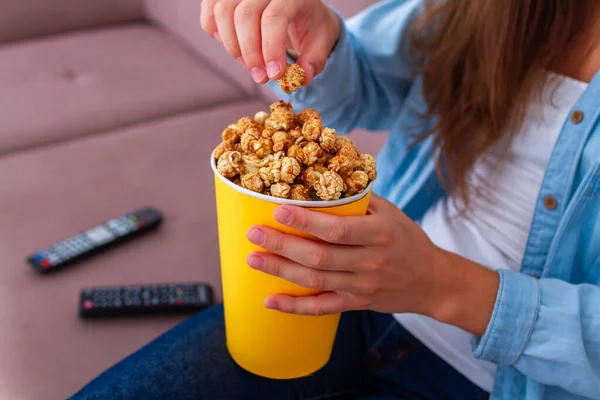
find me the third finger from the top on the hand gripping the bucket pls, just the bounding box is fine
[247,252,355,291]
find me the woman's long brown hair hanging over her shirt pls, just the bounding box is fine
[409,0,598,204]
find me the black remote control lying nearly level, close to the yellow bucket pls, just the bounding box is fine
[79,283,214,318]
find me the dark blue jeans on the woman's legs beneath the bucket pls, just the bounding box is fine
[71,305,488,400]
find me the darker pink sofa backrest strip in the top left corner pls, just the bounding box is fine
[0,0,144,43]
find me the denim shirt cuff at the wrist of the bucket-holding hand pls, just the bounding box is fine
[472,270,541,365]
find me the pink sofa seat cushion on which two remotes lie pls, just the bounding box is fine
[0,102,267,400]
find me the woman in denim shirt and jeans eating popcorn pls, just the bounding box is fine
[73,0,600,400]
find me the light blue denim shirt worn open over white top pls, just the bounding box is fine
[270,0,600,400]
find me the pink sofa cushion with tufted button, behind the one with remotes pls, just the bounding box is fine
[0,25,243,154]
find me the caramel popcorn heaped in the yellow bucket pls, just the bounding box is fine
[214,101,377,201]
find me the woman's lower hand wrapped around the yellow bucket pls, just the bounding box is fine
[248,195,498,334]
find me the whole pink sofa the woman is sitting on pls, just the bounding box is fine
[0,0,384,400]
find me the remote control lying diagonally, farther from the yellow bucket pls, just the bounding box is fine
[27,207,162,273]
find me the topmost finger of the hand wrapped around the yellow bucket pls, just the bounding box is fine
[275,205,391,246]
